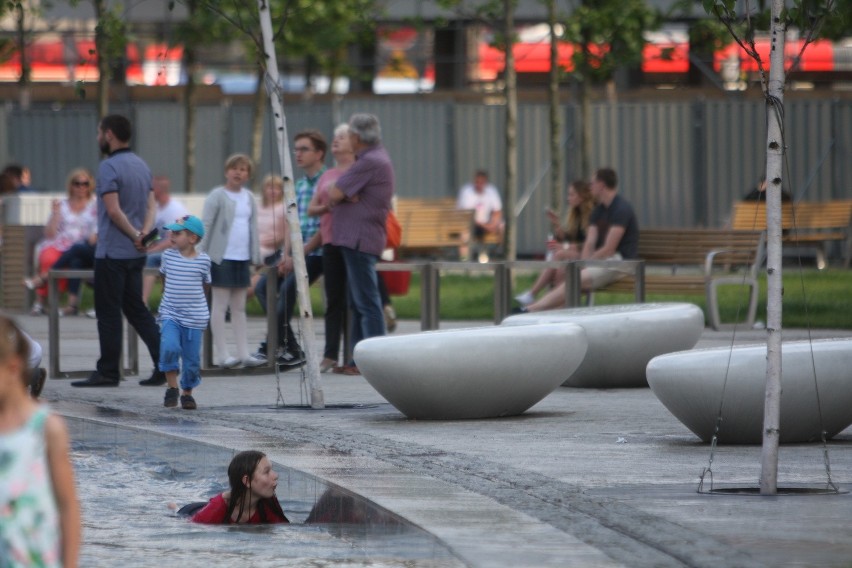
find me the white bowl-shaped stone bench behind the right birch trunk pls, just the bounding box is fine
[648,339,852,444]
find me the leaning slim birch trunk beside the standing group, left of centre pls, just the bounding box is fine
[257,0,325,408]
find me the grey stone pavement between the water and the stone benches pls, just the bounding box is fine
[20,316,852,566]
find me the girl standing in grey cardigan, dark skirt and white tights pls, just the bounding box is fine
[199,154,265,368]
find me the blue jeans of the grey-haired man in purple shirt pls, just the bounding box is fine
[340,247,385,358]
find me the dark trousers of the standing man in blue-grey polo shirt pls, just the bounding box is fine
[95,256,160,379]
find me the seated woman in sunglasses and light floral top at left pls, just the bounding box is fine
[24,168,98,315]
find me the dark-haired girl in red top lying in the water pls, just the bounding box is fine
[190,450,290,525]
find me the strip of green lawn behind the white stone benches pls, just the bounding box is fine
[140,267,852,329]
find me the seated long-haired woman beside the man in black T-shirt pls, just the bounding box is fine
[515,180,595,306]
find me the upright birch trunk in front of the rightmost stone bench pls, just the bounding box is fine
[760,0,786,495]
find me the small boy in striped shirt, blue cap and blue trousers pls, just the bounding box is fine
[159,215,210,410]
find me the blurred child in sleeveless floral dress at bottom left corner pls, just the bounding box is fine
[0,314,80,568]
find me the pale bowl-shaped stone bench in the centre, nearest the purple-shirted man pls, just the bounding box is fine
[355,323,586,420]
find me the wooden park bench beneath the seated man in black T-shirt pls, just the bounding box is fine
[588,229,765,329]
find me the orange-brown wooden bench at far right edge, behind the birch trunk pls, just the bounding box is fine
[731,199,852,269]
